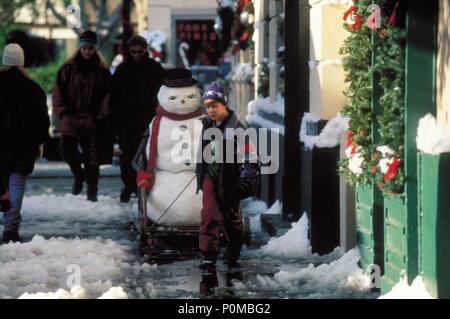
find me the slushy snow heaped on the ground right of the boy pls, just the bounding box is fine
[239,201,376,298]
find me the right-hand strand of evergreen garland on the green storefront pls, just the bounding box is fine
[374,1,406,196]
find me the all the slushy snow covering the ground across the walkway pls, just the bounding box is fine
[0,194,373,298]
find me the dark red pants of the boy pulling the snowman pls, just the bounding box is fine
[199,175,243,263]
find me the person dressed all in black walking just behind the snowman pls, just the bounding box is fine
[110,36,164,202]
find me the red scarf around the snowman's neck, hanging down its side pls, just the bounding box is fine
[136,105,202,190]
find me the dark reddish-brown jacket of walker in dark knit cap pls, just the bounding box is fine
[53,53,111,137]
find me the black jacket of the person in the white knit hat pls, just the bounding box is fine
[0,67,50,175]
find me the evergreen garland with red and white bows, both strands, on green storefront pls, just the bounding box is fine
[339,0,406,196]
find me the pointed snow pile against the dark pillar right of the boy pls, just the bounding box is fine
[261,213,311,258]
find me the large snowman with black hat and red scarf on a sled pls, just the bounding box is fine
[145,69,202,226]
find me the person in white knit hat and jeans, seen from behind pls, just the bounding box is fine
[0,44,50,243]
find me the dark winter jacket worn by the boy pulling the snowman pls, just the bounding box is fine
[196,109,259,205]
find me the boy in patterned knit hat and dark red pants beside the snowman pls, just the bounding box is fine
[197,82,259,280]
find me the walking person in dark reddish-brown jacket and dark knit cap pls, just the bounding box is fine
[53,31,112,202]
